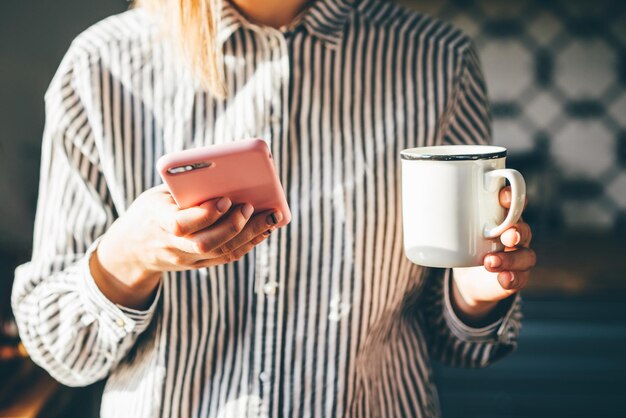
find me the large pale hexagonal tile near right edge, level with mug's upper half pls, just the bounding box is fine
[551,121,616,177]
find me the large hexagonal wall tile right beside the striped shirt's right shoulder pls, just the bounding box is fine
[480,39,533,101]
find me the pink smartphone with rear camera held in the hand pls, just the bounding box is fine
[157,139,291,227]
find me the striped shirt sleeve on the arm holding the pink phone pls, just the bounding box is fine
[11,44,161,386]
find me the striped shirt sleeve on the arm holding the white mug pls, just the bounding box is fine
[420,40,522,367]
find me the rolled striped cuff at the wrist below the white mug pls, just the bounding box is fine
[443,269,521,344]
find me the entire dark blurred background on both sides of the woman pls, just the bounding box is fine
[0,0,626,418]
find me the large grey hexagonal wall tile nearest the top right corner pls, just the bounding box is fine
[555,39,617,99]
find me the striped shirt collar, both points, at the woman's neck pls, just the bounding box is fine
[217,0,356,47]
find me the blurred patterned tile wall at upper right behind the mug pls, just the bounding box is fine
[399,0,626,233]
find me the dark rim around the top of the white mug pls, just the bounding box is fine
[400,145,506,161]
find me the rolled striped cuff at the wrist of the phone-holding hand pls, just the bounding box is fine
[80,238,162,340]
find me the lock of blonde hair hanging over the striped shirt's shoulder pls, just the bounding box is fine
[133,0,226,98]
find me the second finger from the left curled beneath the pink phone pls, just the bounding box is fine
[188,203,254,258]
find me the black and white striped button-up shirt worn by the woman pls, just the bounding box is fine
[12,0,521,418]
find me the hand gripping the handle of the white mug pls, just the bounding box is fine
[453,187,536,323]
